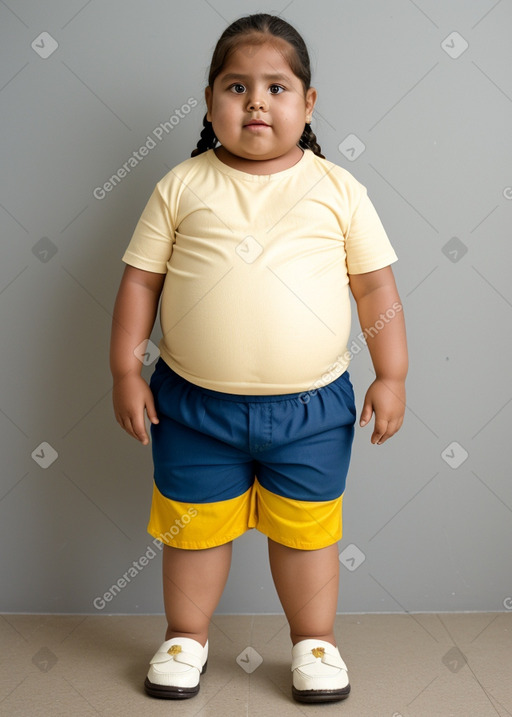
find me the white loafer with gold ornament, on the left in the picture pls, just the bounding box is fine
[144,637,208,700]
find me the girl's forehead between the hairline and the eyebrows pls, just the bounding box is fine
[219,41,300,82]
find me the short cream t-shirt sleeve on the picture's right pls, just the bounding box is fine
[345,185,398,274]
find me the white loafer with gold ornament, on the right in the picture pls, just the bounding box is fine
[292,640,350,702]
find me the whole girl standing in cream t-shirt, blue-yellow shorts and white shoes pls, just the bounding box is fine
[111,14,407,702]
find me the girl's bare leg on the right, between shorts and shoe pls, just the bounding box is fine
[268,538,340,646]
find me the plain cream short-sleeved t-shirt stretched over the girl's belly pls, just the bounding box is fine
[123,150,397,395]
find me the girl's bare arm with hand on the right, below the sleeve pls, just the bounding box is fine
[349,266,408,445]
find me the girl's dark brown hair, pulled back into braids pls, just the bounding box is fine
[191,13,324,158]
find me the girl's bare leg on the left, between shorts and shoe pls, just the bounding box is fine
[163,543,232,646]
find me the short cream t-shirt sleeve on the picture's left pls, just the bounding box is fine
[123,184,175,274]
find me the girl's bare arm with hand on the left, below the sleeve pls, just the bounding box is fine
[110,266,165,445]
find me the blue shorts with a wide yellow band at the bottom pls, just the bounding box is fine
[148,358,356,550]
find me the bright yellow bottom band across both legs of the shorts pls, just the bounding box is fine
[148,480,343,550]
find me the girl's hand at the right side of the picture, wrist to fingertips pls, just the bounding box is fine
[359,378,405,446]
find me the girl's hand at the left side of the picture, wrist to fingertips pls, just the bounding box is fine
[112,373,159,446]
